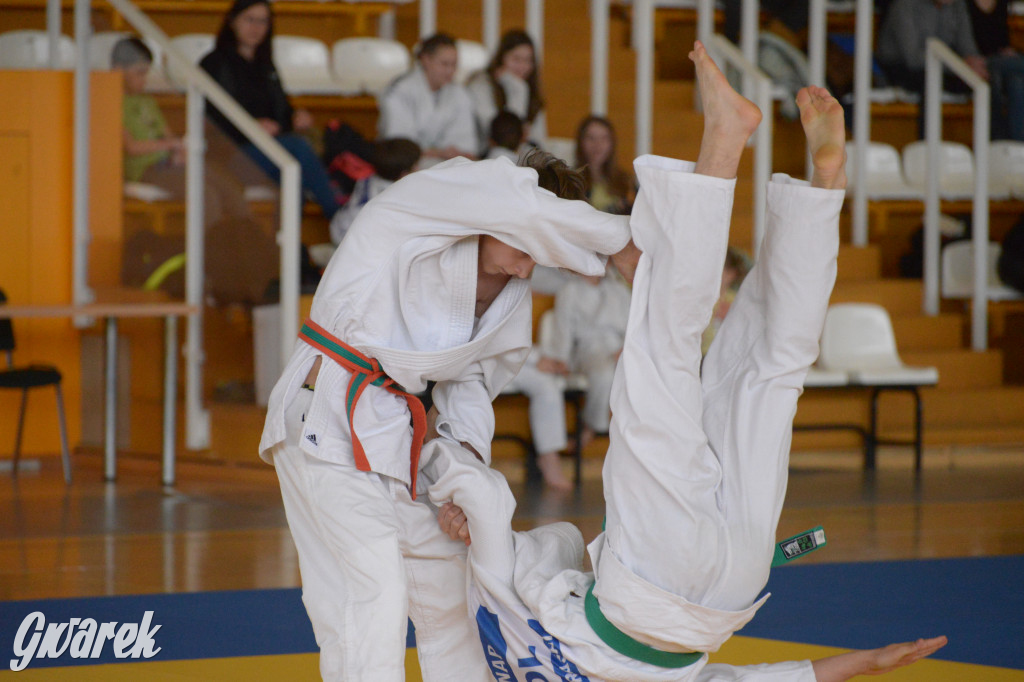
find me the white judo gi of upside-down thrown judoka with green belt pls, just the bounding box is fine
[423,157,844,682]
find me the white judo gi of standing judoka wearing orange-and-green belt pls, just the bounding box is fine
[260,159,630,682]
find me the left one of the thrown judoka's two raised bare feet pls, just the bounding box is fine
[690,40,761,178]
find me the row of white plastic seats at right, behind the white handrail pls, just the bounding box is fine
[846,140,1024,200]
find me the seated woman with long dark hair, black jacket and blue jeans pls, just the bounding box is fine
[200,0,342,220]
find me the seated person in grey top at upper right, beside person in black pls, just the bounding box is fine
[876,0,988,116]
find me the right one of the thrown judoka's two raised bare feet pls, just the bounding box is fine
[797,86,846,189]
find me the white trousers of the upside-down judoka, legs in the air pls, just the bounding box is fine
[595,165,843,614]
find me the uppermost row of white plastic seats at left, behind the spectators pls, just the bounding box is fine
[0,31,489,95]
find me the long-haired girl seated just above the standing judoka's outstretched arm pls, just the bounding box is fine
[575,116,636,215]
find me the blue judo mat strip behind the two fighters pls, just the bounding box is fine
[0,556,1024,670]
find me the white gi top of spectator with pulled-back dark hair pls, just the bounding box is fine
[378,65,480,156]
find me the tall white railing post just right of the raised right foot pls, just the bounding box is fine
[852,0,874,247]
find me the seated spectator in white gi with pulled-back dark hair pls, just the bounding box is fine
[378,33,479,165]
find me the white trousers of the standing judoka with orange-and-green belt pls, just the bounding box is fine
[273,390,489,682]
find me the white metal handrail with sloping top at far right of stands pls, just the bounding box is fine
[921,38,990,350]
